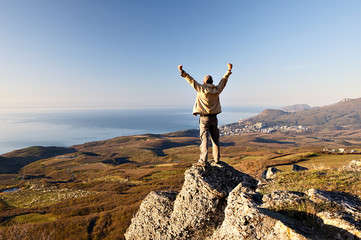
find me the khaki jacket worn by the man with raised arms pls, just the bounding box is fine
[181,71,232,115]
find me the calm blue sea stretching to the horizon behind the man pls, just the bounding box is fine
[0,106,266,155]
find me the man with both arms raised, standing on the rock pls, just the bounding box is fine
[178,63,233,165]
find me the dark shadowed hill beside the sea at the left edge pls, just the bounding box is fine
[0,146,76,174]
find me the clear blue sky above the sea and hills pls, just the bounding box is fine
[0,0,361,107]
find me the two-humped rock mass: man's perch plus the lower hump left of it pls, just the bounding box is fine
[125,162,257,239]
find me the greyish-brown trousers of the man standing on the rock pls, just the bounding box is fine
[199,115,220,163]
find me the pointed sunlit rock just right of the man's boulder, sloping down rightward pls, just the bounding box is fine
[210,187,314,240]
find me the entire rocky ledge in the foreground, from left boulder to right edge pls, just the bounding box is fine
[125,163,361,240]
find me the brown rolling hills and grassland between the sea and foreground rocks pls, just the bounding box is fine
[0,99,361,239]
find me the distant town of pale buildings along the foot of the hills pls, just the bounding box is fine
[219,120,309,136]
